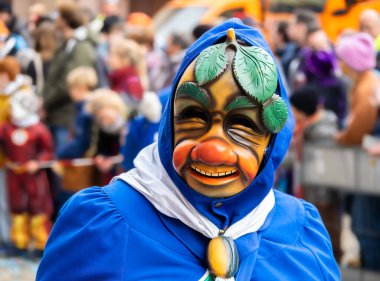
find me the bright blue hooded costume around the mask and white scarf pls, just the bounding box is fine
[37,20,340,281]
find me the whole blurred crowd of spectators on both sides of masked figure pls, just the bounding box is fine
[0,0,380,270]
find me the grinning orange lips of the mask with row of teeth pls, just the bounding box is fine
[188,163,240,186]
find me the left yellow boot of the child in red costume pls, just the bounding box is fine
[11,214,30,250]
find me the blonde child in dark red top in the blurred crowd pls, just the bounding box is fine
[108,39,144,109]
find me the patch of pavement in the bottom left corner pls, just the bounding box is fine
[0,257,39,281]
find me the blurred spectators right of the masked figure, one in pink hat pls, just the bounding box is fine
[273,10,380,270]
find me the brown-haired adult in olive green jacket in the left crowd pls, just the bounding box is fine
[42,3,95,149]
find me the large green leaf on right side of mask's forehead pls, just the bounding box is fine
[232,45,277,103]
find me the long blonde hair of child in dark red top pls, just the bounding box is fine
[111,39,149,90]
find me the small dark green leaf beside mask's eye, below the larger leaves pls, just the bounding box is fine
[262,94,288,134]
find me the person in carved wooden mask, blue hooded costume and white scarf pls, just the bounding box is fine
[37,19,340,281]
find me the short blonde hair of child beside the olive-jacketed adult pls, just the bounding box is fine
[67,66,98,90]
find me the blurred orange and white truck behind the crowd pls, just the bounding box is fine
[154,0,380,46]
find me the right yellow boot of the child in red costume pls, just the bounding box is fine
[30,214,50,251]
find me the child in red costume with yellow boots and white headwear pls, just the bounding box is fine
[0,90,54,254]
